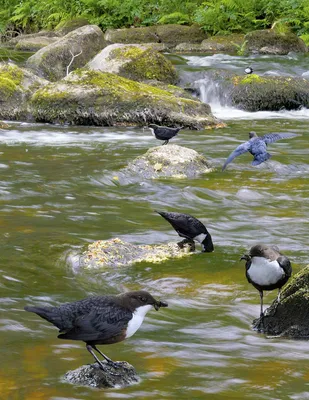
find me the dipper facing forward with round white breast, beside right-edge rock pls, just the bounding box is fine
[241,244,292,318]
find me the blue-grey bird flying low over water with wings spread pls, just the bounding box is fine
[222,132,298,171]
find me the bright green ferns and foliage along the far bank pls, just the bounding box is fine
[0,0,309,35]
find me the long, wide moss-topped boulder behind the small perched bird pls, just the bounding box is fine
[31,70,217,129]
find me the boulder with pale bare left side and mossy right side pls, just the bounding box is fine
[87,44,177,83]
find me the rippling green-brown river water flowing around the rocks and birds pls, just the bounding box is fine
[0,56,309,400]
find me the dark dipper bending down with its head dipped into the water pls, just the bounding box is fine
[155,210,214,253]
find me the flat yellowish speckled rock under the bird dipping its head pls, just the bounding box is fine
[79,238,190,269]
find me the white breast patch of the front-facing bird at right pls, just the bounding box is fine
[248,257,284,286]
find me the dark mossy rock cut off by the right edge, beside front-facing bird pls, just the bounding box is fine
[253,266,309,339]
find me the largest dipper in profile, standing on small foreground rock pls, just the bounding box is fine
[25,290,167,369]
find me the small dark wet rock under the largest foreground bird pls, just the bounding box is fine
[64,361,140,389]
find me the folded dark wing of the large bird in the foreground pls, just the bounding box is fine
[58,304,132,342]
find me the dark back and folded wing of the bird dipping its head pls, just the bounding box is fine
[157,211,208,239]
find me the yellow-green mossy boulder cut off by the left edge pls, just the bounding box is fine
[0,63,48,120]
